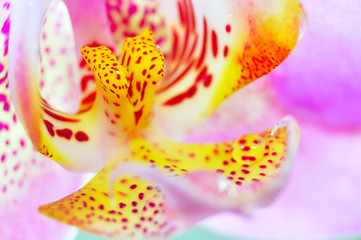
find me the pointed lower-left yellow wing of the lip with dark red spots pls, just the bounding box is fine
[39,166,174,238]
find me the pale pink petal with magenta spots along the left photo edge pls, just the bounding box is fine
[0,1,80,240]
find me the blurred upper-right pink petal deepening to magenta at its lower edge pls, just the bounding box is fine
[273,0,361,128]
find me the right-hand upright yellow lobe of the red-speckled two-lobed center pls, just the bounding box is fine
[119,29,164,128]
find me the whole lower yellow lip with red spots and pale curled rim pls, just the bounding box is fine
[40,116,298,238]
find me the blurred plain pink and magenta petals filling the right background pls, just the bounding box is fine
[193,0,361,239]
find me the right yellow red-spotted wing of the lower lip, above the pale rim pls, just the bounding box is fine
[131,115,298,190]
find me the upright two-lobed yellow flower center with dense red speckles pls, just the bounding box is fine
[81,29,164,133]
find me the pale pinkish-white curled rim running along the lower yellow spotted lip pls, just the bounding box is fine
[108,116,299,228]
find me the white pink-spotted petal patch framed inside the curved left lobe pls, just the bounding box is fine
[40,1,80,112]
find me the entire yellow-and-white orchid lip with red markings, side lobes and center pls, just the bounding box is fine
[3,0,302,238]
